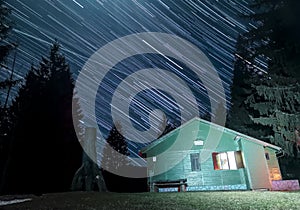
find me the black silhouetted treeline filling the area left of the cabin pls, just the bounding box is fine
[0,1,147,194]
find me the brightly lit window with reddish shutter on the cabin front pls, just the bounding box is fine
[212,151,244,170]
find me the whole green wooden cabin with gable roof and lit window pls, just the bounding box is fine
[140,118,281,192]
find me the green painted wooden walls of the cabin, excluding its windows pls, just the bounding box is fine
[142,118,279,189]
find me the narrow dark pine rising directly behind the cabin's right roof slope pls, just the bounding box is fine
[226,35,268,139]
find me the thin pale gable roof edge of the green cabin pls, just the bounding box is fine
[140,117,281,154]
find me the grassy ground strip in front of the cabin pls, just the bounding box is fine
[0,191,300,210]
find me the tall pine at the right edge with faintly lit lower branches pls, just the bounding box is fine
[246,0,300,156]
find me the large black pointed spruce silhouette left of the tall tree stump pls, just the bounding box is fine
[2,43,82,193]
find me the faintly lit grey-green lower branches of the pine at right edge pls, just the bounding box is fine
[246,75,300,156]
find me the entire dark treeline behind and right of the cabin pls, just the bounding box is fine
[227,0,300,179]
